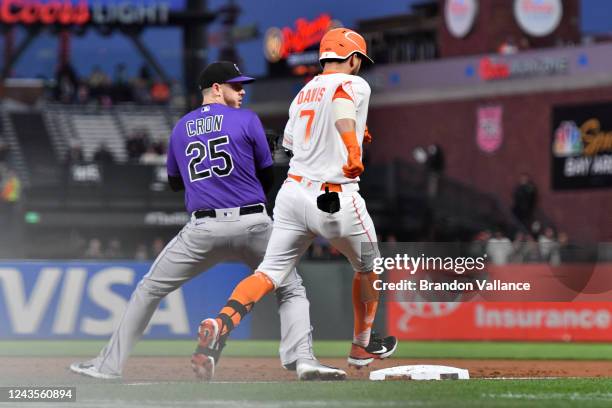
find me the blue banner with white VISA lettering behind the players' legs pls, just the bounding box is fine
[0,261,251,340]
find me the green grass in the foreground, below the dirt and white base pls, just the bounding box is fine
[5,377,612,408]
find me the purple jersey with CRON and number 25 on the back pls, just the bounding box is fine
[167,103,273,213]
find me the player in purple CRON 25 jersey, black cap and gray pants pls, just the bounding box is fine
[70,62,346,380]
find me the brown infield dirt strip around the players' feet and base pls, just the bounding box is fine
[0,357,612,383]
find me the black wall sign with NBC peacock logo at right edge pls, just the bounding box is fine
[551,101,612,190]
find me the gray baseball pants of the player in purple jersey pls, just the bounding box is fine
[92,209,314,375]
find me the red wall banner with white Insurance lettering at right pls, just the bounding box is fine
[385,258,612,342]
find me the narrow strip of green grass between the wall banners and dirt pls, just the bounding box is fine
[0,340,612,360]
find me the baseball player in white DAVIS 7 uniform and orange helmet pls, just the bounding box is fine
[194,28,397,374]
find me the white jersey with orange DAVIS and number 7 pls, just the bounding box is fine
[283,73,371,184]
